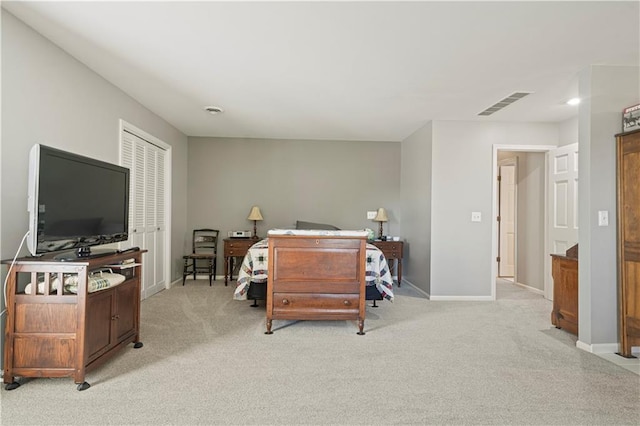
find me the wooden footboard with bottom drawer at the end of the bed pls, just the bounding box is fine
[266,231,367,335]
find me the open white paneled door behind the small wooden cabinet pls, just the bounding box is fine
[545,143,578,300]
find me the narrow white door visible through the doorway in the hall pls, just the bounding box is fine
[498,159,517,278]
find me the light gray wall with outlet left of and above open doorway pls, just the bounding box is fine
[431,121,558,299]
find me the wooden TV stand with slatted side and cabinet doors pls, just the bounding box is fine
[2,250,146,390]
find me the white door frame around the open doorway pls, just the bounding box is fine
[490,144,557,300]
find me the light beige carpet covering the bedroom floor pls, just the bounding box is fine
[0,280,640,425]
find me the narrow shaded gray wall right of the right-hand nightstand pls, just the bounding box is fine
[400,122,433,294]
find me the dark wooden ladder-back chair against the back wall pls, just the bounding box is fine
[182,229,220,286]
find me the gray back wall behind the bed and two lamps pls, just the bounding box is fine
[184,137,401,271]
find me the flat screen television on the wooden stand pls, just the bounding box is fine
[27,144,129,260]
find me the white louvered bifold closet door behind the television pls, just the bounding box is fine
[120,130,167,299]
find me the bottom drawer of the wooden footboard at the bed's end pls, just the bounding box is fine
[273,293,359,319]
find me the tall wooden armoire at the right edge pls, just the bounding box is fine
[616,130,640,358]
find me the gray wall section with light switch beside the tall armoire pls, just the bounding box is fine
[578,66,640,352]
